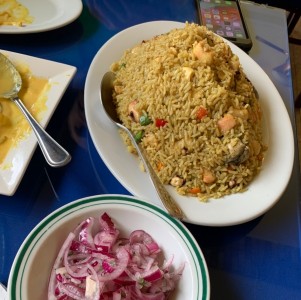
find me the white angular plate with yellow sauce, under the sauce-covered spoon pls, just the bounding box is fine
[0,50,76,196]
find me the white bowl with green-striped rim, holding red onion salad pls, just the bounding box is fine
[8,195,210,300]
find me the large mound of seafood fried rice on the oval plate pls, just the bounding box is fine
[111,23,266,201]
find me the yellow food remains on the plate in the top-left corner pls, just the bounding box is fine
[0,0,33,26]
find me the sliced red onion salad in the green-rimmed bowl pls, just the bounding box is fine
[48,213,184,300]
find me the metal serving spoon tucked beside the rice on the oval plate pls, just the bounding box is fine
[101,72,184,220]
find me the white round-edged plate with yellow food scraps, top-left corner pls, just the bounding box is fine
[0,0,83,34]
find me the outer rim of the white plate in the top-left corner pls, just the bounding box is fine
[0,0,83,34]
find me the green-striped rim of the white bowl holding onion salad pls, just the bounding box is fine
[7,194,210,300]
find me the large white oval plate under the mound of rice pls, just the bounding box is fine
[85,21,294,226]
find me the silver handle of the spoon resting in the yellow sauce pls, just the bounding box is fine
[12,97,71,167]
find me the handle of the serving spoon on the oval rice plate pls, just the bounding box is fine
[122,124,185,220]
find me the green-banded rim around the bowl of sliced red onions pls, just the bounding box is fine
[8,195,209,300]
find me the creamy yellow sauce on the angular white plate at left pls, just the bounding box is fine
[0,65,50,164]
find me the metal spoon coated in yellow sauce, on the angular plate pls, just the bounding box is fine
[0,53,71,167]
